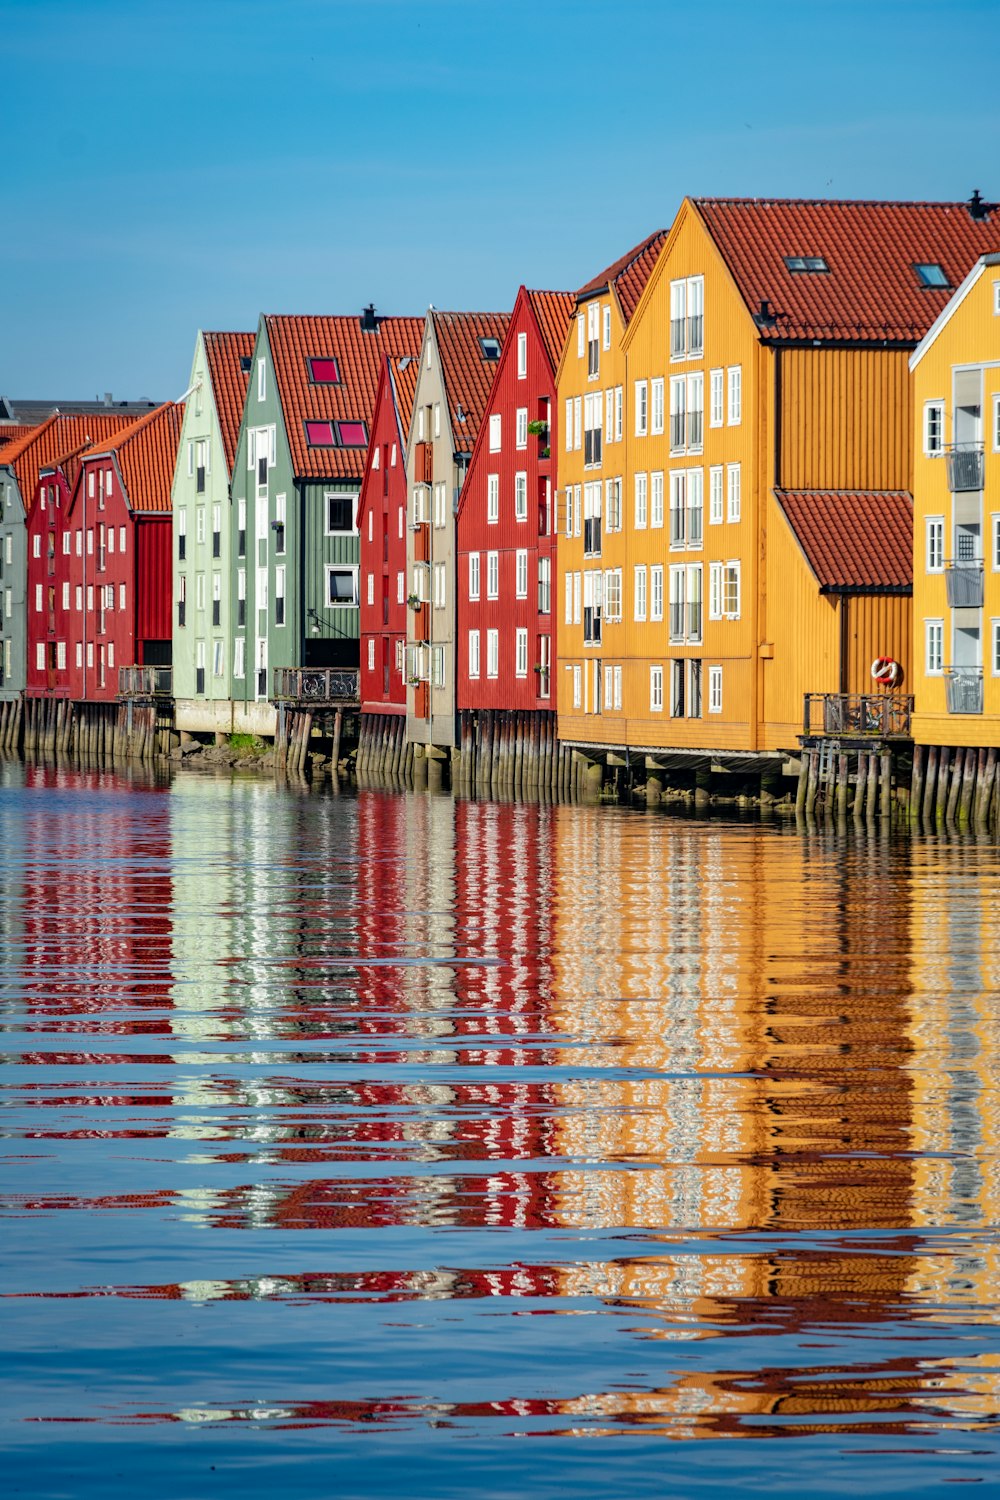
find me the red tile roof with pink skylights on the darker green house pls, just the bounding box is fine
[264,317,424,480]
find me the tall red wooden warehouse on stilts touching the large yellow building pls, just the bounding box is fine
[456,287,574,791]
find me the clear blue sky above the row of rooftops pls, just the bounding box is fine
[0,0,1000,398]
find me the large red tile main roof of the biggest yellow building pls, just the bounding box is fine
[693,198,1000,344]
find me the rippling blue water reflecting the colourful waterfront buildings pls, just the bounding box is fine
[0,764,1000,1500]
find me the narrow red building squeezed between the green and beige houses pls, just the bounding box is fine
[358,348,420,729]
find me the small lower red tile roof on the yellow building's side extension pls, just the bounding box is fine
[774,489,913,594]
